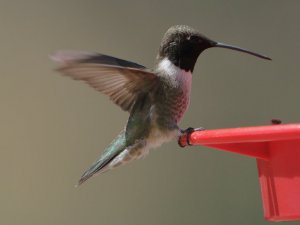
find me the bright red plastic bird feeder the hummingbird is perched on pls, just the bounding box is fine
[179,123,300,221]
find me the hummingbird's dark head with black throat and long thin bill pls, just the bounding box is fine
[158,25,270,72]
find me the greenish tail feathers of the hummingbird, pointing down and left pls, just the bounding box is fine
[76,131,126,186]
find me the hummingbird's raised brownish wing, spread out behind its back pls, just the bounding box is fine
[51,51,158,112]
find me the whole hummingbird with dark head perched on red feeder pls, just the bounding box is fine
[52,25,271,185]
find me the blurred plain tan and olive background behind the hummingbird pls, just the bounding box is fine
[0,0,300,225]
